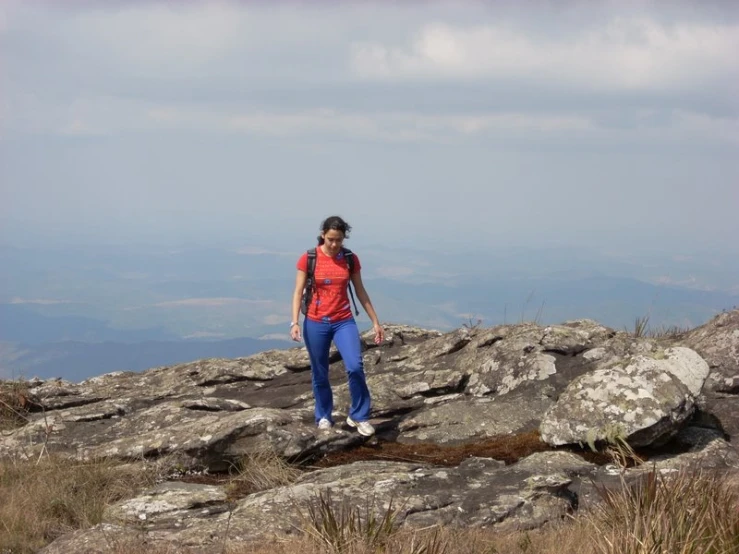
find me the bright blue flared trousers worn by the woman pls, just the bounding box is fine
[303,317,371,423]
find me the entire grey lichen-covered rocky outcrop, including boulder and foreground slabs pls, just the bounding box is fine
[0,312,739,552]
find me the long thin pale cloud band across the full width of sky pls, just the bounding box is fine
[5,90,739,144]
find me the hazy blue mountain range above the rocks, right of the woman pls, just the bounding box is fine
[368,274,739,330]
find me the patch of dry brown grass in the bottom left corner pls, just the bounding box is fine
[0,457,158,554]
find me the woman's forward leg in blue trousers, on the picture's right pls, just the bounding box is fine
[333,318,372,421]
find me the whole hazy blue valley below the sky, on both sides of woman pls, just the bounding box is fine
[0,245,739,380]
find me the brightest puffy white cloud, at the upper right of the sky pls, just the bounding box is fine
[351,18,739,90]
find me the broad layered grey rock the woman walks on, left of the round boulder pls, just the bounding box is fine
[0,320,632,464]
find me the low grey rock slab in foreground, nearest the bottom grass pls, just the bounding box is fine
[98,453,592,547]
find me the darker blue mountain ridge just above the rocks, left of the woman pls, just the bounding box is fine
[0,338,295,381]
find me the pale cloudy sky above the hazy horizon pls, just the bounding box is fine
[0,0,739,254]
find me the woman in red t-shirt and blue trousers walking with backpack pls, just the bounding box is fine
[290,216,385,437]
